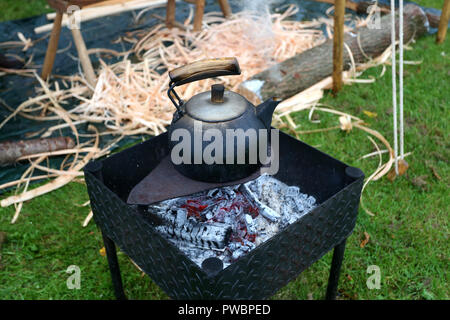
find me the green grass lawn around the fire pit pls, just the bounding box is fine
[0,0,450,299]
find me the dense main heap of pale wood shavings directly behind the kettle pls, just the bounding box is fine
[73,6,325,135]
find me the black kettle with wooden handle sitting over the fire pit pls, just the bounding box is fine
[167,58,280,183]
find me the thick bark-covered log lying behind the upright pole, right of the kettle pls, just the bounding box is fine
[239,4,428,103]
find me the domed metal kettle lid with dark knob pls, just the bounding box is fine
[185,84,251,122]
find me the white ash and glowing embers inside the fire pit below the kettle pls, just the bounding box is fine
[148,175,316,267]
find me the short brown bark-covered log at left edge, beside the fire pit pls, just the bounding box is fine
[0,137,75,166]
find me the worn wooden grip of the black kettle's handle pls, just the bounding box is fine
[169,58,241,86]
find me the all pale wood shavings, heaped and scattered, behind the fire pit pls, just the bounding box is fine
[0,6,393,222]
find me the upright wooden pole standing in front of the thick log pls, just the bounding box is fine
[332,0,345,94]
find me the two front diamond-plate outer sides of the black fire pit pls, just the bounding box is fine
[85,131,363,299]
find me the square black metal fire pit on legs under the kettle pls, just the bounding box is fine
[84,132,364,299]
